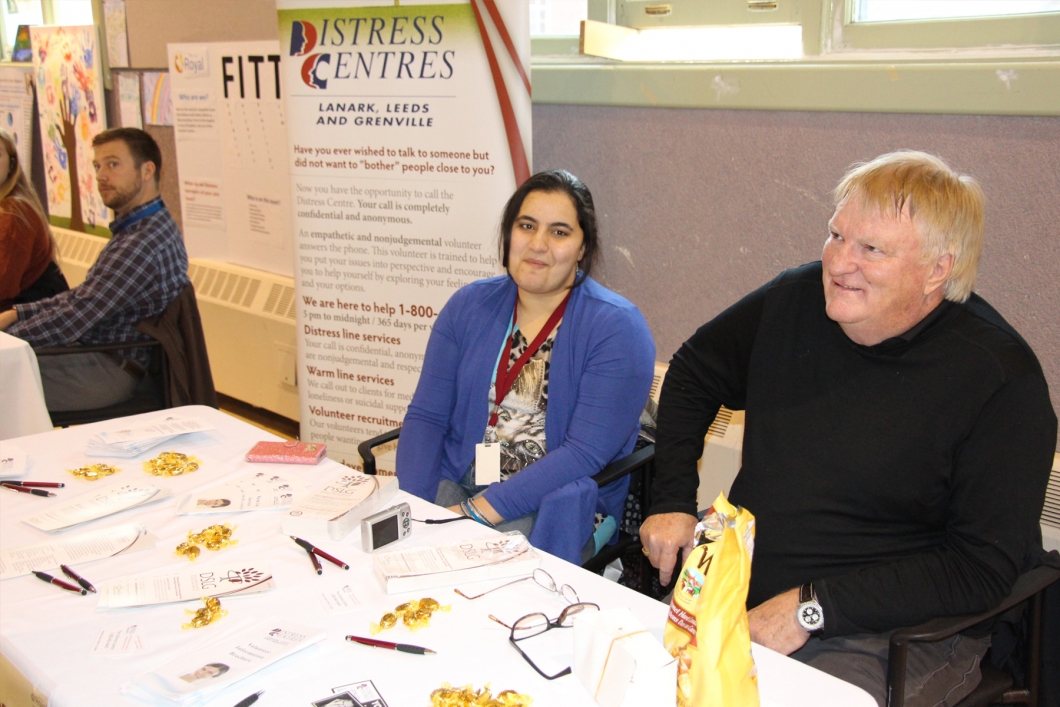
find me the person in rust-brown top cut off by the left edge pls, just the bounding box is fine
[0,130,70,312]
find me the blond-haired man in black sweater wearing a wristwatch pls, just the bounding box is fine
[640,152,1057,706]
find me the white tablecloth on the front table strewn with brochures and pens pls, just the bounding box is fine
[0,407,875,707]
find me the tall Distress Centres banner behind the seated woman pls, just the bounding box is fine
[277,0,531,466]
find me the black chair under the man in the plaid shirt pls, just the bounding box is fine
[34,339,173,427]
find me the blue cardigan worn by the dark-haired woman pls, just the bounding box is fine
[398,276,655,562]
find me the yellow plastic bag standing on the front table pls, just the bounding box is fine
[664,493,759,707]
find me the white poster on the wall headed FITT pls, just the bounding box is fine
[169,40,295,277]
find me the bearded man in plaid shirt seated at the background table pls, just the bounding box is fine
[0,127,188,411]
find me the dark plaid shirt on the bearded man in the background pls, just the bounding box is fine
[7,197,188,367]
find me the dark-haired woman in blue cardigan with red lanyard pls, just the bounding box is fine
[396,170,655,563]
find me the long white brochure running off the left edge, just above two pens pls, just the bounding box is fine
[0,523,158,580]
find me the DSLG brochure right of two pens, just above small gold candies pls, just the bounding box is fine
[98,562,276,609]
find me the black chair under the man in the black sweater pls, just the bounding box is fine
[887,551,1060,707]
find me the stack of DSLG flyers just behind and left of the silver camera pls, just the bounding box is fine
[283,471,398,541]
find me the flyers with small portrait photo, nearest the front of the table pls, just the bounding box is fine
[121,617,328,707]
